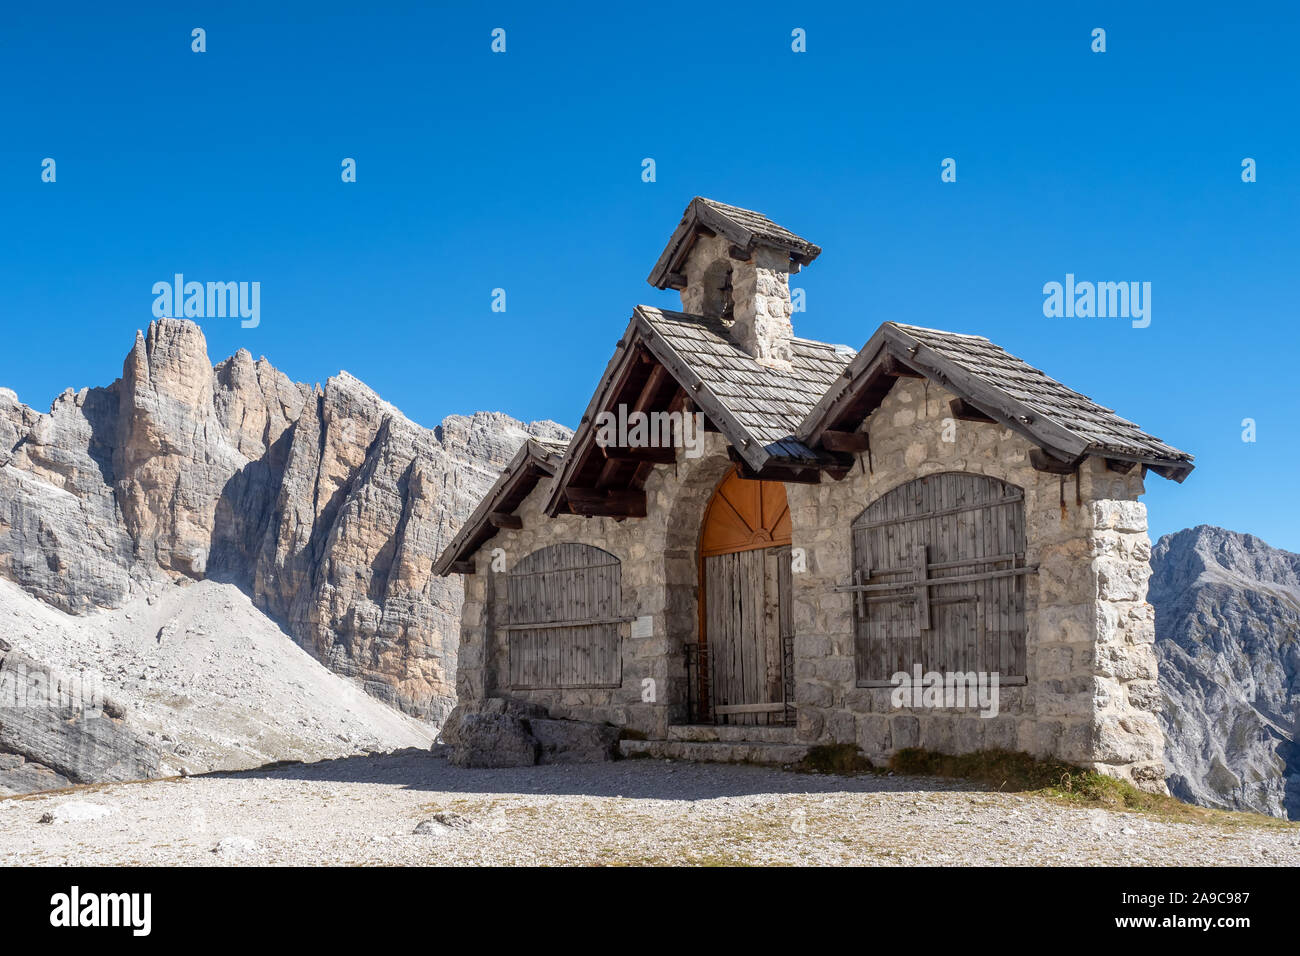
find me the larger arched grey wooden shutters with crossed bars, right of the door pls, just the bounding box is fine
[852,472,1035,687]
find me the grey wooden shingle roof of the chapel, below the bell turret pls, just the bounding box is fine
[434,314,1193,574]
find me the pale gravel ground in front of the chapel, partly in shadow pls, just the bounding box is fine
[0,750,1300,866]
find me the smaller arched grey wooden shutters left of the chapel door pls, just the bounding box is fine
[504,544,629,691]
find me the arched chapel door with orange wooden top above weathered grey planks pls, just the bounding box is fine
[697,468,794,724]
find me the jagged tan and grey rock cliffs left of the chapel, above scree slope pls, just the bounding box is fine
[0,319,568,728]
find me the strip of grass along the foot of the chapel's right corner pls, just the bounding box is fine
[889,748,1300,829]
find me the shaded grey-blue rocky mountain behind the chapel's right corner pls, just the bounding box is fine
[1149,524,1300,819]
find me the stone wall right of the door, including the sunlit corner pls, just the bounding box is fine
[787,378,1164,787]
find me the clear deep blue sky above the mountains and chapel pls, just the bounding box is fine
[0,3,1300,550]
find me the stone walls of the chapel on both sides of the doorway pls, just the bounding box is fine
[458,378,1164,788]
